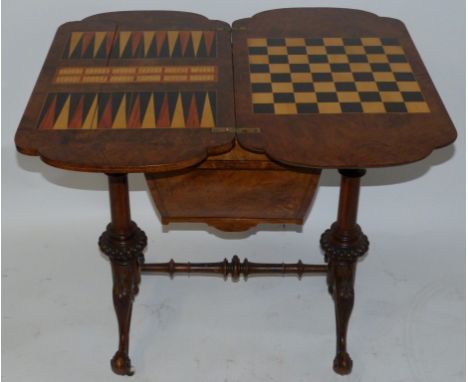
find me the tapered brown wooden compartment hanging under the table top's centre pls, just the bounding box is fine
[146,146,320,231]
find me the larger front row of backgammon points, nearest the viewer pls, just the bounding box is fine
[37,91,216,130]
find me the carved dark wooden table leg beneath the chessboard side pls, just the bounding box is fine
[320,170,369,375]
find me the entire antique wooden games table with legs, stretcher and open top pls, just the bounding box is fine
[15,8,456,375]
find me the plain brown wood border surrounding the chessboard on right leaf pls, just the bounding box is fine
[232,8,456,168]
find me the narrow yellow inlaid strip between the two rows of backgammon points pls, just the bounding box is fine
[53,66,217,84]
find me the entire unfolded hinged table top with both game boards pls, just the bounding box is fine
[16,8,456,172]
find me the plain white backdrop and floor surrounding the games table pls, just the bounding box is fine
[2,0,465,382]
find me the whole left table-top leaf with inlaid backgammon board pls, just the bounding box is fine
[15,11,235,172]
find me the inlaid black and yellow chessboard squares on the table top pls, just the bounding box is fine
[248,37,430,115]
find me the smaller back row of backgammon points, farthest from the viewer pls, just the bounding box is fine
[62,30,216,59]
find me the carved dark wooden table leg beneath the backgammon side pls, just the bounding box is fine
[99,174,147,375]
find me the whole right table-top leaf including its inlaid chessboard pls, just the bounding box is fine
[233,8,456,168]
